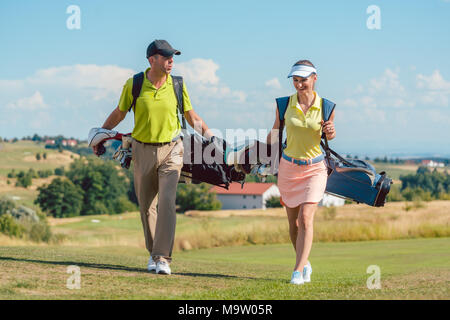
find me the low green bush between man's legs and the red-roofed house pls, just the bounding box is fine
[176,183,222,212]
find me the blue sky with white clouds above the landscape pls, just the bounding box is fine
[0,0,450,156]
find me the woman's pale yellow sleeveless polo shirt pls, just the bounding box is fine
[284,91,322,159]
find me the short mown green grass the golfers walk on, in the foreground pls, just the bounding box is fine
[0,238,450,299]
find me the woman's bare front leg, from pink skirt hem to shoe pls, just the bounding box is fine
[294,203,317,272]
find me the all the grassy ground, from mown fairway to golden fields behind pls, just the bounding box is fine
[0,141,450,300]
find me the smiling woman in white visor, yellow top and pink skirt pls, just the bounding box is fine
[267,60,336,284]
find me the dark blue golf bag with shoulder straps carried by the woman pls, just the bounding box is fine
[277,97,392,207]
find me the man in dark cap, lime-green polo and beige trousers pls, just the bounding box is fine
[94,40,212,274]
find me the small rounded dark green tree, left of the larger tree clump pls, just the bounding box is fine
[34,178,84,218]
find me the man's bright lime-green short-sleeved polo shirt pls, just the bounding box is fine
[119,68,192,143]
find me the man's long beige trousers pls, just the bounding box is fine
[132,139,184,263]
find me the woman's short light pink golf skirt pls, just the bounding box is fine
[278,157,328,208]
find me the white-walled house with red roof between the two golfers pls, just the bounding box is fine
[210,182,280,209]
